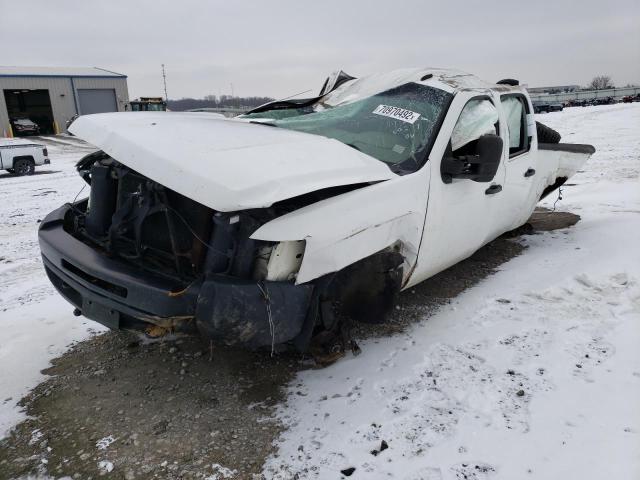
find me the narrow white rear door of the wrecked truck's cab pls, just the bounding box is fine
[500,93,541,231]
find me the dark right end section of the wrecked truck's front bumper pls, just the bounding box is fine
[196,277,313,348]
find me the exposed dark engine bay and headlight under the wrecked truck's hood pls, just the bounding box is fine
[72,152,376,284]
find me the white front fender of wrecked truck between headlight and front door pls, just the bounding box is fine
[251,168,430,285]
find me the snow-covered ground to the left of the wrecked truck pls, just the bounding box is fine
[0,137,102,437]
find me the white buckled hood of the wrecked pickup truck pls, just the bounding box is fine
[69,112,396,212]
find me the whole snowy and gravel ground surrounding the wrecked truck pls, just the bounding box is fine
[0,104,640,480]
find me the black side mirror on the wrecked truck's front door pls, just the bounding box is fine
[440,135,502,183]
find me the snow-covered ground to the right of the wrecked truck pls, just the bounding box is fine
[265,104,640,480]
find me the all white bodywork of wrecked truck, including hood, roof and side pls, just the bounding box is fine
[71,69,590,288]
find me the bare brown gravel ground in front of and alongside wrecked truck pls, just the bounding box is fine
[0,209,579,480]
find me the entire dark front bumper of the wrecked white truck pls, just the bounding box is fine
[38,205,313,348]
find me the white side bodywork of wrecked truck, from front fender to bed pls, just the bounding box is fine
[252,83,589,288]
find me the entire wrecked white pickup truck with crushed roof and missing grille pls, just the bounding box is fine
[39,69,594,350]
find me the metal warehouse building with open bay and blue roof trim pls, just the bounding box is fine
[0,66,129,137]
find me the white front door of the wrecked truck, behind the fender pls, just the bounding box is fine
[411,91,508,284]
